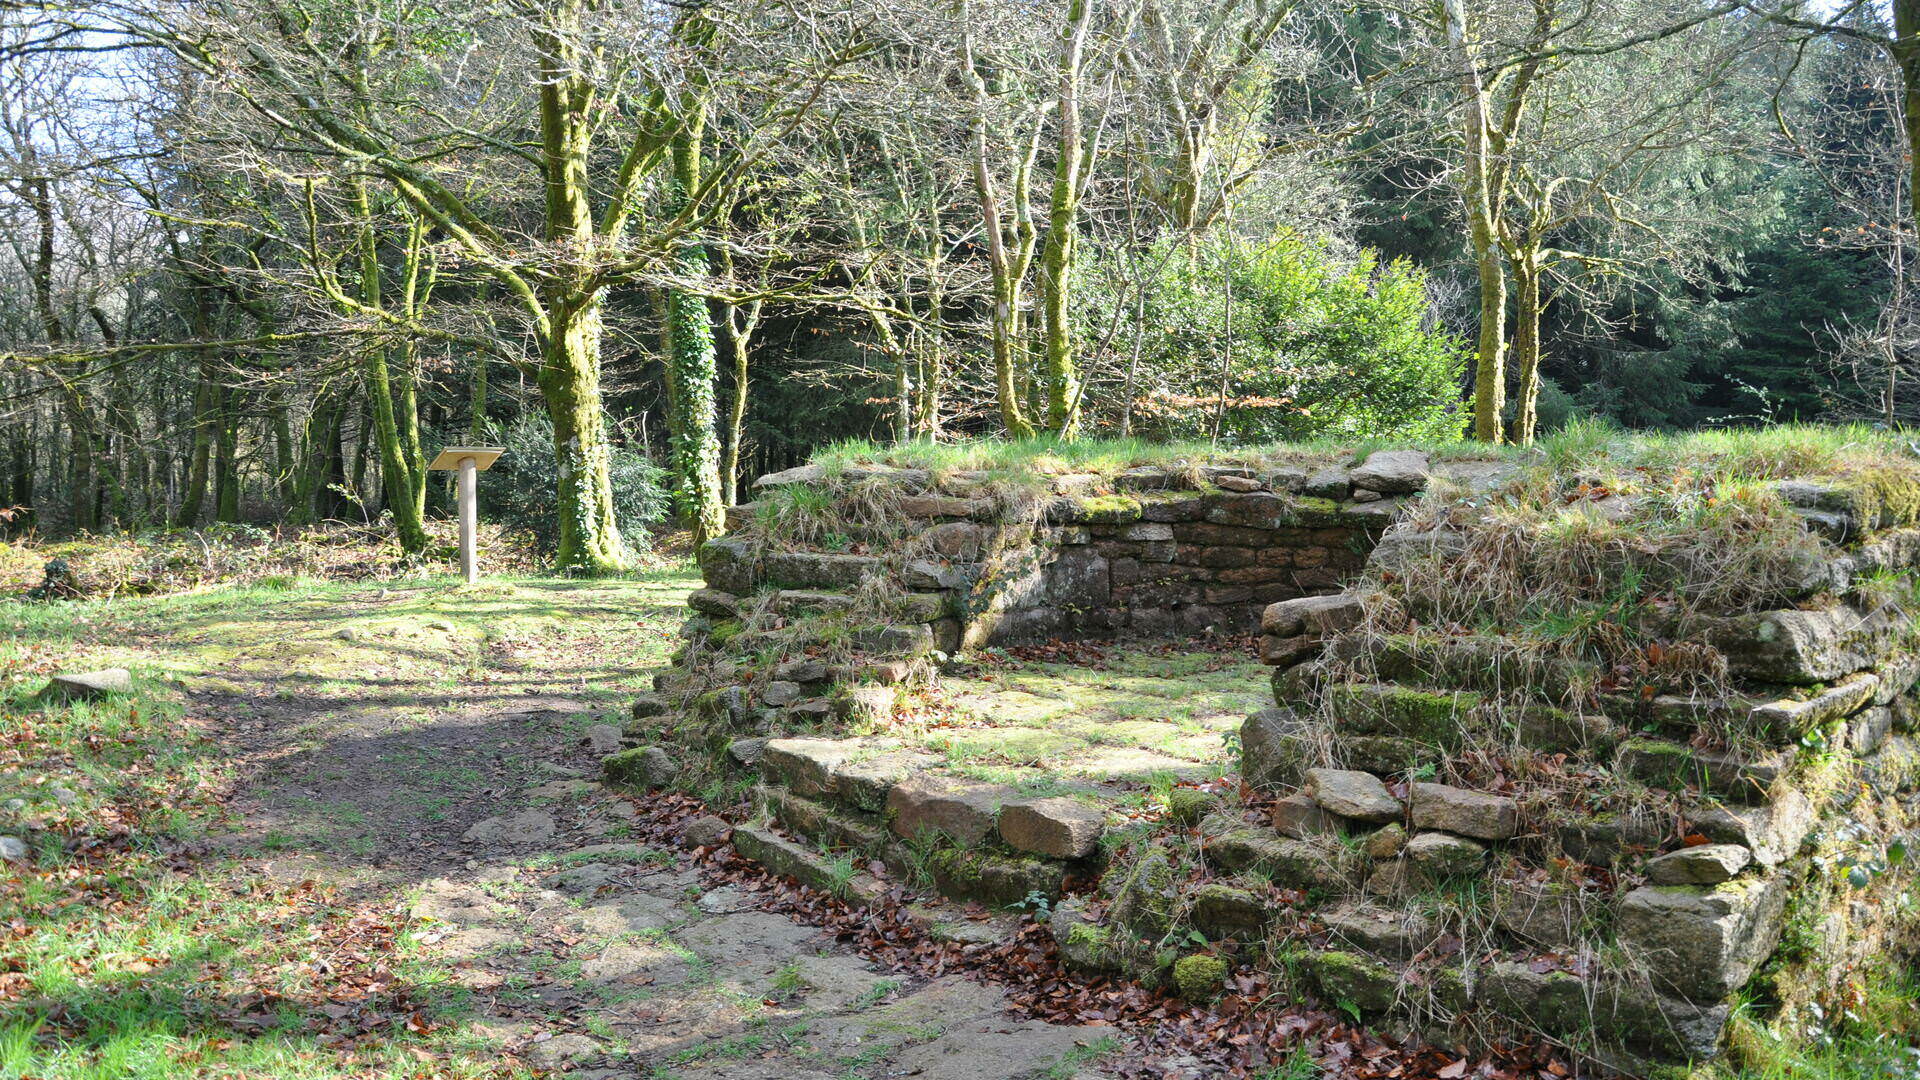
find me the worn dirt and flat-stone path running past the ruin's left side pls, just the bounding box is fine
[178,576,1112,1080]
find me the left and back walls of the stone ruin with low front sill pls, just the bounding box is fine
[609,454,1419,903]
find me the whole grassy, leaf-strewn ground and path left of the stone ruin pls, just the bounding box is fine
[0,575,1117,1080]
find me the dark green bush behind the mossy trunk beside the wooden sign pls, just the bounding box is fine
[480,411,666,557]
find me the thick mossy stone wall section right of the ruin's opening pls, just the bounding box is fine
[1228,466,1920,1074]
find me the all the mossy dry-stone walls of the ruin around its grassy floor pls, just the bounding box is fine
[609,443,1920,1074]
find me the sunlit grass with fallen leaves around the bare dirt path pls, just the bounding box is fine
[0,575,689,1080]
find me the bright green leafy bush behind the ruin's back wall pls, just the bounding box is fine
[1081,233,1467,444]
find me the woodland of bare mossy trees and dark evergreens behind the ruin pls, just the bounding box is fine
[0,0,1920,573]
